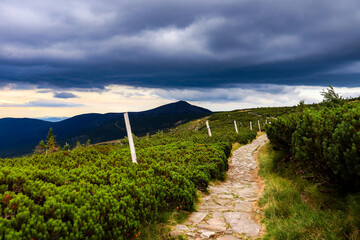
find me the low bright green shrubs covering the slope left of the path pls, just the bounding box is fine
[0,110,268,239]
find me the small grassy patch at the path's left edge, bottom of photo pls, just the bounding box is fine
[137,211,189,240]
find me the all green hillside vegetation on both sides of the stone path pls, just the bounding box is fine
[0,91,360,240]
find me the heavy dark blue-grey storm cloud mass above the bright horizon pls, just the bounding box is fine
[0,0,360,88]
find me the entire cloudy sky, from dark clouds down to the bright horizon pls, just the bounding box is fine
[0,0,360,118]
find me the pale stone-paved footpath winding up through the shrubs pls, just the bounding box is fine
[171,135,267,240]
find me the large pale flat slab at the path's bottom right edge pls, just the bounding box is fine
[224,212,261,236]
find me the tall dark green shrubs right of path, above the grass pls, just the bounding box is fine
[266,99,360,191]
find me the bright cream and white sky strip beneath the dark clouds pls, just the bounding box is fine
[0,84,360,119]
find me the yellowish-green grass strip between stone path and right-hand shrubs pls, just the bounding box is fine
[258,143,360,240]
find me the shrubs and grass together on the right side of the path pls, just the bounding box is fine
[259,86,360,239]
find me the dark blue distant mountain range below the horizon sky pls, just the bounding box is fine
[0,101,211,158]
